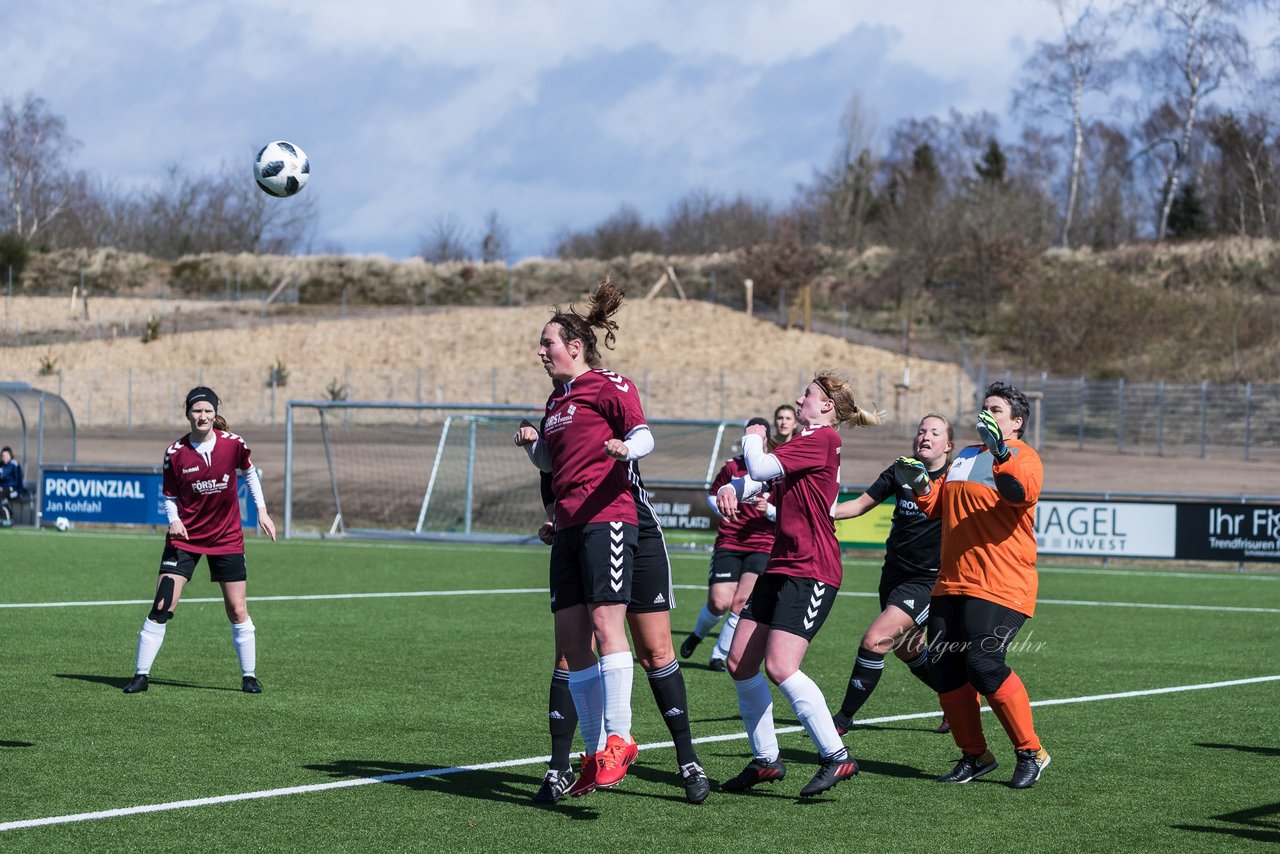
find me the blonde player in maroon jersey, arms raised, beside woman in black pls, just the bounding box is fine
[717,371,881,796]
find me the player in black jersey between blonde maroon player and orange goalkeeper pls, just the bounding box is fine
[835,414,955,735]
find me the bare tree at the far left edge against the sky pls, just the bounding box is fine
[0,92,79,243]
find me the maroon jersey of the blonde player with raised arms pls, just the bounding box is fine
[765,426,844,588]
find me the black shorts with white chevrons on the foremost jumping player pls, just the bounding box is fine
[549,522,637,611]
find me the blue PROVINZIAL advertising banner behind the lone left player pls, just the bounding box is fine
[40,469,257,528]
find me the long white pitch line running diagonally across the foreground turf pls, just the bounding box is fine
[0,675,1280,832]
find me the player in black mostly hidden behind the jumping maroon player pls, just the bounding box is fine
[534,462,710,804]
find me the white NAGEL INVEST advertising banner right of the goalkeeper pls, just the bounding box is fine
[1036,501,1178,557]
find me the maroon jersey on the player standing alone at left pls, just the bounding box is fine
[163,430,253,554]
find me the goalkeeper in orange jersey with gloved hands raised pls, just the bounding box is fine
[897,383,1050,789]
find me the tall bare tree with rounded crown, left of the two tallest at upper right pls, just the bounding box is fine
[1014,0,1121,247]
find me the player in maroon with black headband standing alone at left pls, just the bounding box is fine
[124,385,275,694]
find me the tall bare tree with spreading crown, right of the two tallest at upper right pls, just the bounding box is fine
[1132,0,1254,241]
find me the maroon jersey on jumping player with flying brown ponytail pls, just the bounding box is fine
[541,370,645,529]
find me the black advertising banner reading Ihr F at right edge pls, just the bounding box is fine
[1178,503,1280,561]
